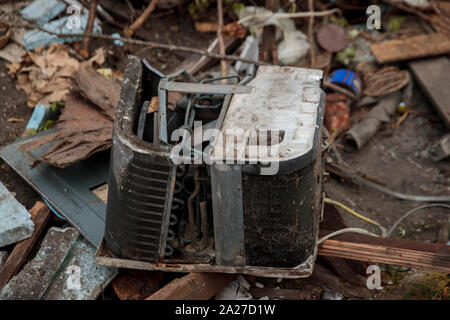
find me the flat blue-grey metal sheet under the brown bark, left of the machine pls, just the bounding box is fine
[0,130,109,247]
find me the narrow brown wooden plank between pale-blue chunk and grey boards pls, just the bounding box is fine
[0,201,51,290]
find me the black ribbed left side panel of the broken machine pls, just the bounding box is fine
[105,56,176,261]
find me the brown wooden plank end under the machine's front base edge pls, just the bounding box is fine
[146,273,234,300]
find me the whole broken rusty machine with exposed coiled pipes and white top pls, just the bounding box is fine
[96,57,325,278]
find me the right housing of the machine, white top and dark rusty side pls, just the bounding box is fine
[211,66,325,268]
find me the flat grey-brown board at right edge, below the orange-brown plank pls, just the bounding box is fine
[409,57,450,129]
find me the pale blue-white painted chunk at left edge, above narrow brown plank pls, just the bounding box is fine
[0,182,34,248]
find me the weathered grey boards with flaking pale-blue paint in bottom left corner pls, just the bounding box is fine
[0,227,117,300]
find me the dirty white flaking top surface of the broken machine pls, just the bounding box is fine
[213,66,323,162]
